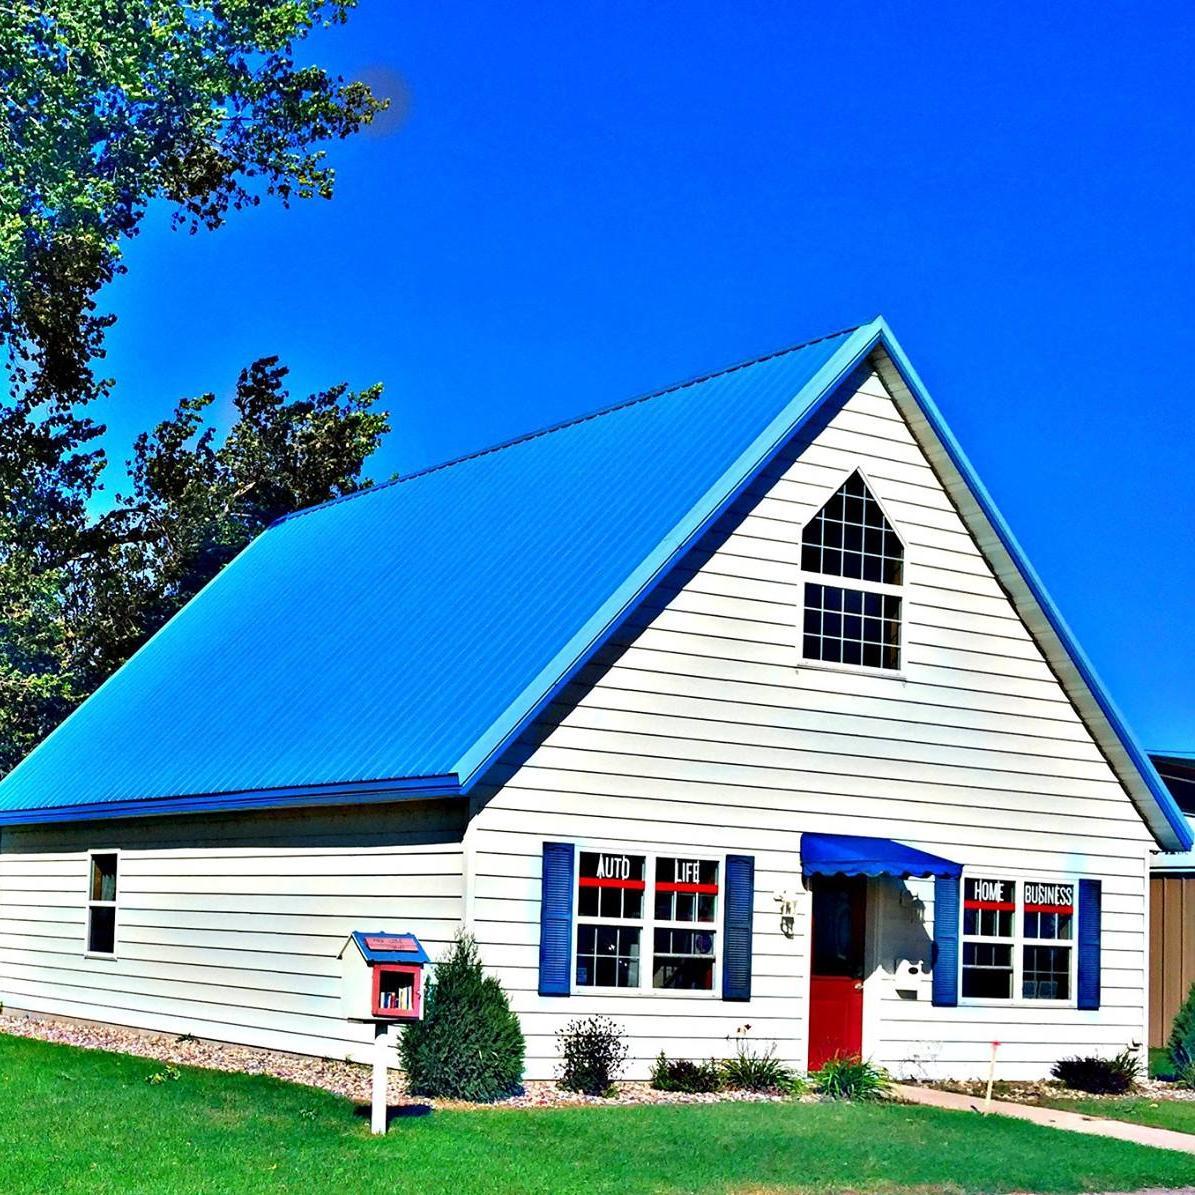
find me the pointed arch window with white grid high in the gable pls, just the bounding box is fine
[801,472,905,670]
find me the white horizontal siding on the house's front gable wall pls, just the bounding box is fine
[470,379,1150,1078]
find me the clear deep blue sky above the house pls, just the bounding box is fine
[97,7,1195,749]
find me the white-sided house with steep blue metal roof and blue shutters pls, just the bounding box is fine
[0,320,1191,1079]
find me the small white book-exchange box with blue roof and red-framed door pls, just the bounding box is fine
[341,930,428,1022]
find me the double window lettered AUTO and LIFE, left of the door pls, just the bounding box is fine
[575,851,722,992]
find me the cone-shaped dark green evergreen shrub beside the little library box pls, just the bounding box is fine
[399,933,525,1103]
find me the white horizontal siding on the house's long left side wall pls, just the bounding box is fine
[0,802,465,1058]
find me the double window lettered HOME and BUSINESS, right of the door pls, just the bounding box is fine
[962,876,1076,1000]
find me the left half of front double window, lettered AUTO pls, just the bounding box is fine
[576,851,648,987]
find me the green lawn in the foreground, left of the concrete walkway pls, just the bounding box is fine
[0,1036,1195,1195]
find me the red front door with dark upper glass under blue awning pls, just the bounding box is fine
[809,876,868,1071]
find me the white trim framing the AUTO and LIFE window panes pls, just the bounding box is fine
[569,840,727,1000]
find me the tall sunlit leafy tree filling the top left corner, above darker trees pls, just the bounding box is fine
[0,0,385,410]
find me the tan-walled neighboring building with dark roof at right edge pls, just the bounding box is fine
[1150,753,1195,1046]
